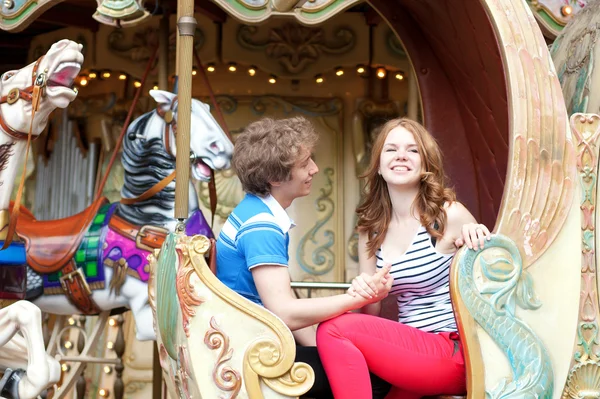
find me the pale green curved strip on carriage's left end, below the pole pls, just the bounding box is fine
[155,233,179,360]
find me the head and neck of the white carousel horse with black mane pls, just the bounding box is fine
[118,90,233,228]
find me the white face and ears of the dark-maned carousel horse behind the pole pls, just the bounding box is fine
[142,90,233,181]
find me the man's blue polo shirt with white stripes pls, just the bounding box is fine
[217,194,294,305]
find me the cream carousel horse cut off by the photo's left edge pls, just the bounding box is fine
[0,40,83,398]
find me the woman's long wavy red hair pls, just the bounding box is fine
[356,118,456,256]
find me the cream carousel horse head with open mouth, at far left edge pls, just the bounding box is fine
[0,40,83,138]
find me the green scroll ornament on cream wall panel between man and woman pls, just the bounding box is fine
[296,168,335,276]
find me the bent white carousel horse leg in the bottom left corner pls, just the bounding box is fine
[0,301,60,398]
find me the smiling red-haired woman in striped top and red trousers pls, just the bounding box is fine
[317,118,478,399]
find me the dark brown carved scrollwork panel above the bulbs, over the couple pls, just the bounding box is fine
[222,13,369,79]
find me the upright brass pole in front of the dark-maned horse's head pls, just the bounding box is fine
[175,0,196,220]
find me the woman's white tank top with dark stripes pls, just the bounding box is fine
[375,226,457,332]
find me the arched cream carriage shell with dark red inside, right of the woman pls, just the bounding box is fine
[370,0,581,398]
